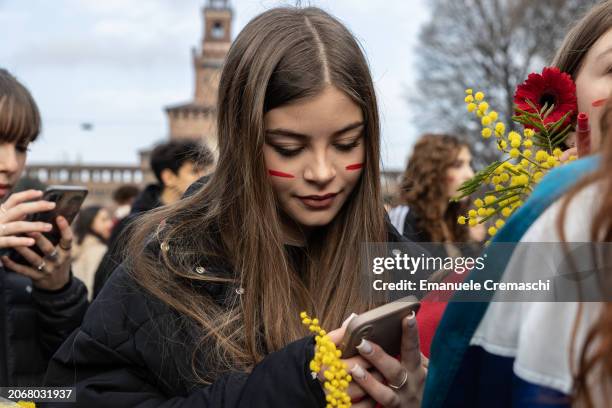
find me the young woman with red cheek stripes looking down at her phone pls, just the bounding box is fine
[47,8,423,407]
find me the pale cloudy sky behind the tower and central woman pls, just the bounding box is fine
[0,0,429,169]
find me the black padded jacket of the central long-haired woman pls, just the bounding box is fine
[45,268,325,408]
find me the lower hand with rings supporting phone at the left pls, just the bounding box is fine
[2,203,72,290]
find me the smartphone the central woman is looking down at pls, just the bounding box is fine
[340,296,421,358]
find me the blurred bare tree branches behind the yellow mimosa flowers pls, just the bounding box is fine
[407,0,597,165]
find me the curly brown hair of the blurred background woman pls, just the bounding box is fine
[400,134,469,242]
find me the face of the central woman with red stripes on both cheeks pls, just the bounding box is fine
[263,86,365,234]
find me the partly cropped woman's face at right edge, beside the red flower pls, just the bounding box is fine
[576,29,612,149]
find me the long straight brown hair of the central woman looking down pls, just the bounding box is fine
[127,8,386,382]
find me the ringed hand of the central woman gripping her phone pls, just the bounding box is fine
[351,314,429,408]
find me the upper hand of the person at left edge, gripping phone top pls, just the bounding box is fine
[0,190,55,248]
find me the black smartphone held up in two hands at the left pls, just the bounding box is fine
[9,186,88,265]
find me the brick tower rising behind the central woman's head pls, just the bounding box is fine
[166,0,232,152]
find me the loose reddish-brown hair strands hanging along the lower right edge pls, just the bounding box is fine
[557,95,612,408]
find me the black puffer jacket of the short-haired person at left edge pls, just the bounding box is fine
[0,258,88,387]
